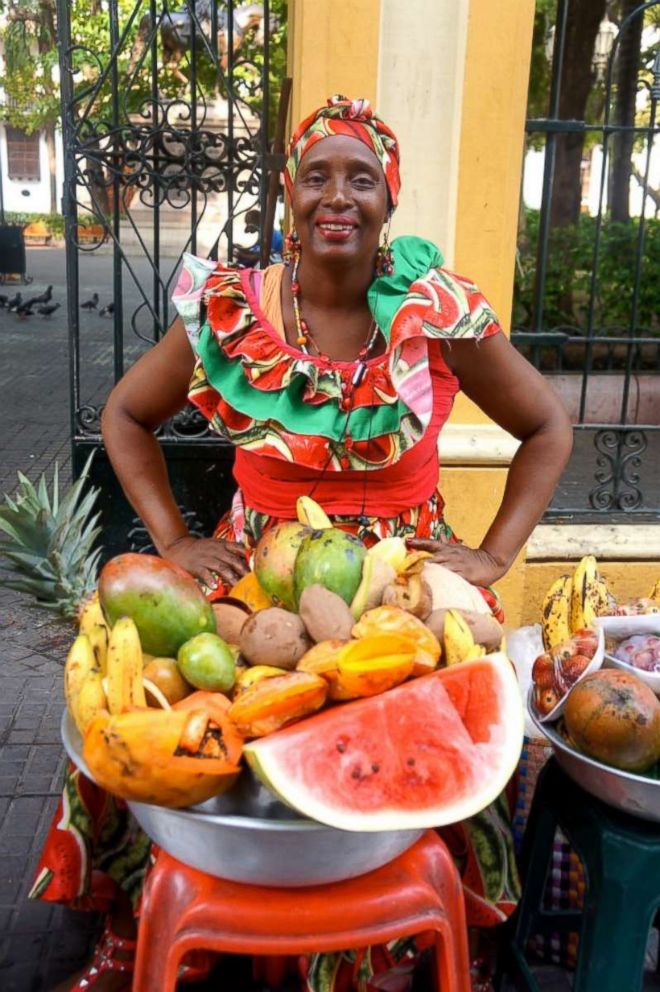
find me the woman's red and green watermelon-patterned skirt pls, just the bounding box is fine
[30,492,520,992]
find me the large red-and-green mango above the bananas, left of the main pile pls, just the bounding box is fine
[99,553,216,658]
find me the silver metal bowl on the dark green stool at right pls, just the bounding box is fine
[528,693,660,823]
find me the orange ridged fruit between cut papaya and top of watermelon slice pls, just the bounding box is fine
[229,672,328,737]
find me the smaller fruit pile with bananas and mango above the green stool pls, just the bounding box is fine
[532,556,660,778]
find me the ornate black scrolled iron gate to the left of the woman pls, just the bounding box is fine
[57,0,285,554]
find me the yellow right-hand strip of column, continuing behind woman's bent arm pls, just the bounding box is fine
[440,0,534,624]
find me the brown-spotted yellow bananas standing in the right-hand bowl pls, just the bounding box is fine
[541,555,610,651]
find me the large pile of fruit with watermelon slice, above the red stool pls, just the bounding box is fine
[65,499,522,829]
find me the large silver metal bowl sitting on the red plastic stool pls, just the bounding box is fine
[61,710,424,887]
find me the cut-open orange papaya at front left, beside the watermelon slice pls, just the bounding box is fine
[83,693,243,808]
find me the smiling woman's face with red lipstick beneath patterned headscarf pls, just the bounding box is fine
[292,135,388,263]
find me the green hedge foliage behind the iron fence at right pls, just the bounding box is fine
[513,210,660,336]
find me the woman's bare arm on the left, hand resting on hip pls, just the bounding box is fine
[102,318,247,586]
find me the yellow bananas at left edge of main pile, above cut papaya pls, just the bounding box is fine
[64,617,147,734]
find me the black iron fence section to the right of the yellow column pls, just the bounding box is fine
[512,0,660,522]
